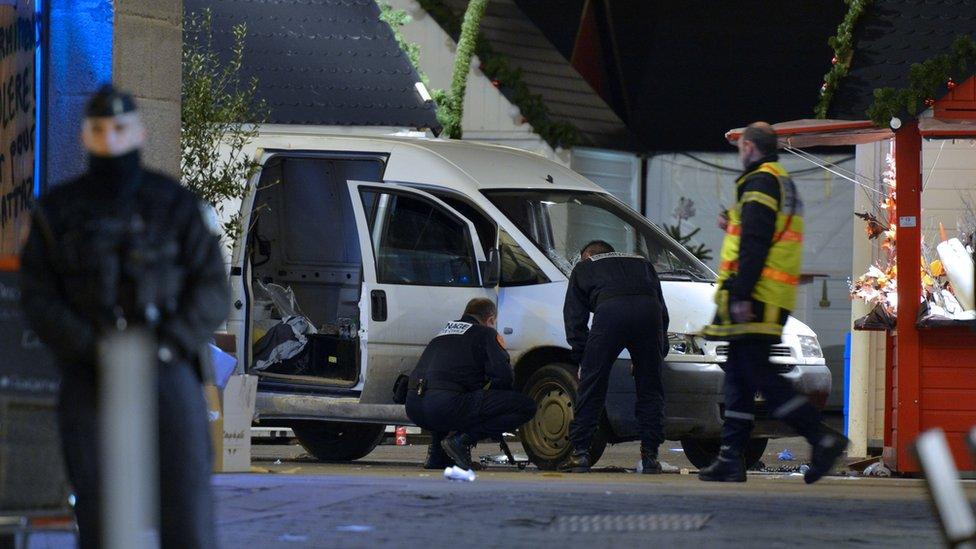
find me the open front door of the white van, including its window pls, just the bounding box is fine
[349,181,497,404]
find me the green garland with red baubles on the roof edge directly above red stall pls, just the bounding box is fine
[867,34,976,127]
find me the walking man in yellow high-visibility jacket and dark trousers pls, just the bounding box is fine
[698,122,848,483]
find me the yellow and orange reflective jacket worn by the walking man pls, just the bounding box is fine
[704,162,803,339]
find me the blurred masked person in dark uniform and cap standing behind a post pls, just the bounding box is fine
[21,86,229,548]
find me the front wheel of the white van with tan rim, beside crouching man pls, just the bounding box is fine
[519,363,608,470]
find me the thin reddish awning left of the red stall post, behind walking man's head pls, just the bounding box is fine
[725,119,894,148]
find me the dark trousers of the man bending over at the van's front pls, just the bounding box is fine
[569,295,664,450]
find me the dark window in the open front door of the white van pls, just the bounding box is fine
[362,190,479,286]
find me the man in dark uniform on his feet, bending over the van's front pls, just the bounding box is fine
[561,240,668,474]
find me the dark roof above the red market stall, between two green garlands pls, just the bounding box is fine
[827,0,976,119]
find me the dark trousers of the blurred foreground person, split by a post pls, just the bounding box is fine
[58,362,217,549]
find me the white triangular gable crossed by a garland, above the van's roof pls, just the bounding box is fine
[382,0,568,164]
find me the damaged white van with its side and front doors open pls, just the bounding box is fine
[228,133,830,469]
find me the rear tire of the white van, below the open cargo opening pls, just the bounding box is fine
[291,421,386,462]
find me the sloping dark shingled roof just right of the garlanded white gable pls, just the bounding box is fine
[444,0,641,150]
